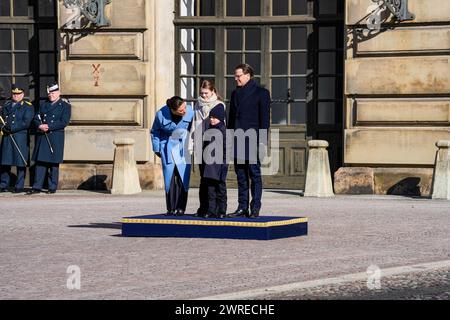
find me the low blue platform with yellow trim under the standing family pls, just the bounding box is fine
[122,214,308,240]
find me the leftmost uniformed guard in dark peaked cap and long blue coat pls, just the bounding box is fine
[0,84,34,193]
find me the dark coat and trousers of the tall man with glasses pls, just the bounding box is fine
[228,79,270,217]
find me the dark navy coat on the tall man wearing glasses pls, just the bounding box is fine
[228,79,271,160]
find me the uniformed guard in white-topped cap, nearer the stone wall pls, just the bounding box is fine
[27,83,71,195]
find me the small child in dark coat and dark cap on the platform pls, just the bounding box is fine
[200,104,228,218]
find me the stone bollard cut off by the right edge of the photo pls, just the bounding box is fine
[431,140,450,200]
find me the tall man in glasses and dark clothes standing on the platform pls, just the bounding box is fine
[228,64,270,218]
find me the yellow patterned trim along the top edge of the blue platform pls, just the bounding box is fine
[122,218,308,228]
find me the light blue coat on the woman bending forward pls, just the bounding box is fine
[151,106,194,193]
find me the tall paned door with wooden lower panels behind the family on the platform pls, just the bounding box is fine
[174,0,344,188]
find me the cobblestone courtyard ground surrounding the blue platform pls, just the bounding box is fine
[0,189,450,299]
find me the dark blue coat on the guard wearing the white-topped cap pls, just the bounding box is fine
[33,99,71,163]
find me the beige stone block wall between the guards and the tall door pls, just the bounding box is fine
[58,0,175,188]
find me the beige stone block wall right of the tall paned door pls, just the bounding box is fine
[344,0,450,193]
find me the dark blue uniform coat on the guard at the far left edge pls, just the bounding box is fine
[0,100,34,167]
